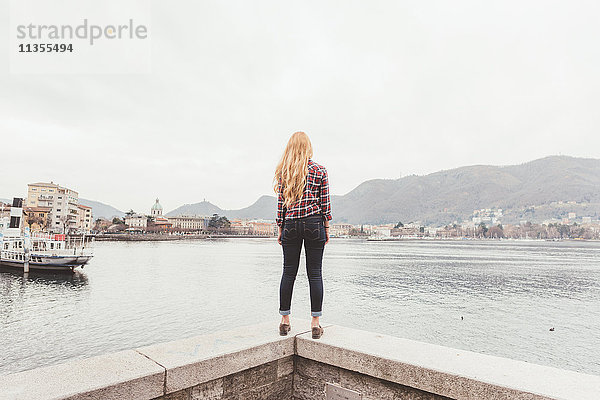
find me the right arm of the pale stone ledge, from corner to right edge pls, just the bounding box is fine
[296,325,600,400]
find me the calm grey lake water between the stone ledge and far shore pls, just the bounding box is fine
[0,239,600,375]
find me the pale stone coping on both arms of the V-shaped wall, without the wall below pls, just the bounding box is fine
[0,319,600,400]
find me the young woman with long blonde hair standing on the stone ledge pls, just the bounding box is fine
[274,132,331,339]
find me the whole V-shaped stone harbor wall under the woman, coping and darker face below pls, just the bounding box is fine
[0,318,600,400]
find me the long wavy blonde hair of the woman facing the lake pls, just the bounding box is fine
[273,132,313,207]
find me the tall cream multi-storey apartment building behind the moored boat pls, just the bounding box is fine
[26,182,86,233]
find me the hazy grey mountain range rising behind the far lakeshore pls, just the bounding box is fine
[167,156,600,225]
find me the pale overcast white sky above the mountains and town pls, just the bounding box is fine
[0,0,600,212]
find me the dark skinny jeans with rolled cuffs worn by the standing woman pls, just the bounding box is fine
[279,214,327,317]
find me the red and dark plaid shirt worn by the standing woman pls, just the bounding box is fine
[276,159,331,226]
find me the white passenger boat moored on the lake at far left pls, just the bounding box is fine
[0,198,93,271]
